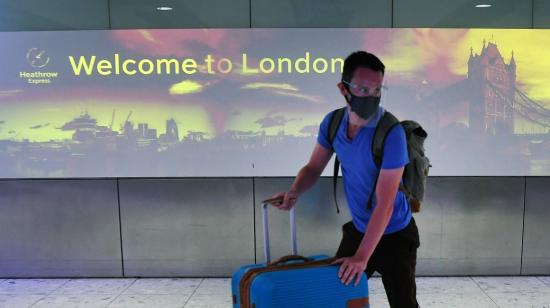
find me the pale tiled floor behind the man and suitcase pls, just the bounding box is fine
[0,277,550,308]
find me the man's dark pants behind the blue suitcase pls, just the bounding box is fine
[336,218,420,308]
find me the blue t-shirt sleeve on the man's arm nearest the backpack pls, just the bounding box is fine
[382,125,409,169]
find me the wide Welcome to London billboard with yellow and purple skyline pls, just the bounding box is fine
[0,29,550,178]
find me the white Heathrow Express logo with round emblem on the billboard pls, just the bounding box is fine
[19,47,59,85]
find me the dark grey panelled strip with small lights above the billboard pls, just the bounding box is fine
[0,0,550,31]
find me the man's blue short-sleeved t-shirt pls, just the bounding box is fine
[317,107,411,234]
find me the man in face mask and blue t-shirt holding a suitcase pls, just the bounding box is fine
[274,51,420,308]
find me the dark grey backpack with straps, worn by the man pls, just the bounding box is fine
[328,107,431,213]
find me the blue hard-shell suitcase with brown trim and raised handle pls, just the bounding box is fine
[231,203,369,308]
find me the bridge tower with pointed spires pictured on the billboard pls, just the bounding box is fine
[468,40,516,135]
